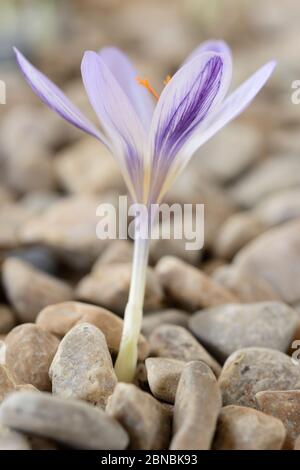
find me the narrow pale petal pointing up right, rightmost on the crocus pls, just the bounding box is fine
[184,61,276,156]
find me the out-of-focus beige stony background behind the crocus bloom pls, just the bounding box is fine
[0,0,300,290]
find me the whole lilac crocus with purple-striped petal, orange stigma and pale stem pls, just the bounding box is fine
[15,41,275,381]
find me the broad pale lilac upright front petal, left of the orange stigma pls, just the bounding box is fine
[81,51,146,200]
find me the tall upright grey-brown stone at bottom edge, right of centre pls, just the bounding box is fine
[170,361,222,450]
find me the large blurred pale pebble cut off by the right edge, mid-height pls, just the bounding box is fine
[234,219,300,304]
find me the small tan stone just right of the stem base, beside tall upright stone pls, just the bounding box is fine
[146,357,186,404]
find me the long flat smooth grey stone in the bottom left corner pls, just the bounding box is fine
[0,392,128,450]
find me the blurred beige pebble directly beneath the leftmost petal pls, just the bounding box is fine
[55,137,125,193]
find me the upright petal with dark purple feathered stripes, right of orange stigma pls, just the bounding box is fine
[150,52,232,202]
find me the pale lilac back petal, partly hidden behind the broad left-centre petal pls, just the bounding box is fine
[99,47,154,130]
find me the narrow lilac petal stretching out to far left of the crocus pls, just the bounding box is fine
[14,48,109,147]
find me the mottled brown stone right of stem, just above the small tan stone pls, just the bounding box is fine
[149,325,221,376]
